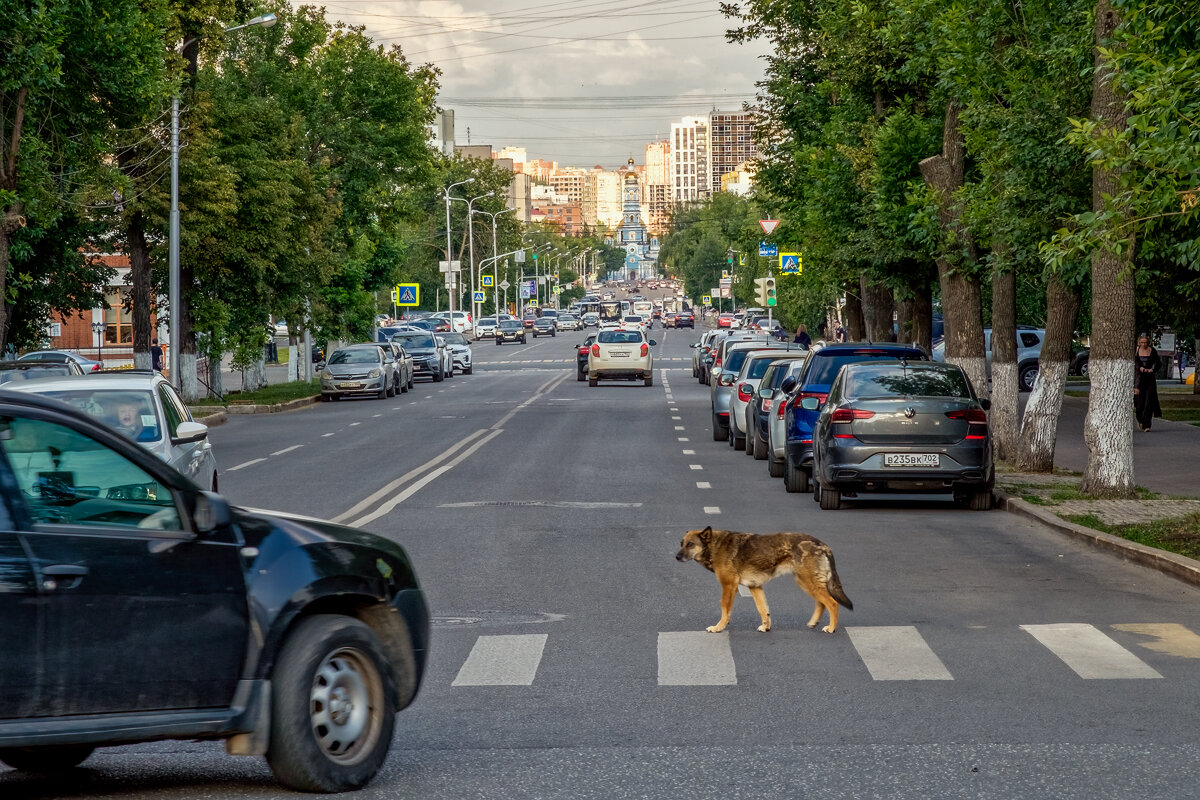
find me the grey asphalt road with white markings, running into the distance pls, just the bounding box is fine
[7,321,1200,800]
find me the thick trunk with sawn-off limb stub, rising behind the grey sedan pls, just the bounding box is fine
[919,100,989,397]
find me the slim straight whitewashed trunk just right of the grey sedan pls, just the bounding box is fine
[991,266,1020,463]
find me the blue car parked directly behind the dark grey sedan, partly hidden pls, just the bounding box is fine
[782,342,929,492]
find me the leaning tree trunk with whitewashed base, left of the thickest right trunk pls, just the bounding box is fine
[1017,275,1080,473]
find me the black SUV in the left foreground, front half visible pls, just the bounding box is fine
[0,391,430,792]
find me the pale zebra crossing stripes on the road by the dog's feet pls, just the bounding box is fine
[436,622,1200,687]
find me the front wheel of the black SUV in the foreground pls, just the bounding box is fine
[266,614,396,792]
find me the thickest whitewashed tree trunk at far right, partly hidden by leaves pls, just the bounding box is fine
[1080,0,1135,497]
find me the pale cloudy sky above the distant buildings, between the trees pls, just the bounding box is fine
[309,0,763,168]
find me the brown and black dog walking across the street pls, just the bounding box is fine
[676,525,854,633]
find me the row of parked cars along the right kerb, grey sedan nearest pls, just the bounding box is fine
[692,330,995,510]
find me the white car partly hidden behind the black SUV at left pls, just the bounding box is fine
[7,369,217,491]
